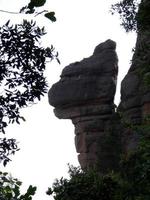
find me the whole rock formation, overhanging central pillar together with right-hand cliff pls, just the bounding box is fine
[49,0,150,173]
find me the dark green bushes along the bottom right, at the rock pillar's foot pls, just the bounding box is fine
[47,125,150,200]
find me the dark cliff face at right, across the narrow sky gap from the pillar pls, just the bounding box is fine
[118,33,150,125]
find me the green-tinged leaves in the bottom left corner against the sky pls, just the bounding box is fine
[0,172,36,200]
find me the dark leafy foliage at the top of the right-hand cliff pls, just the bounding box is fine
[111,0,150,32]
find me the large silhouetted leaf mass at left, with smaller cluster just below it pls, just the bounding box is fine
[0,20,59,164]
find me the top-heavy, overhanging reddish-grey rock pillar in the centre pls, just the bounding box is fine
[49,40,118,171]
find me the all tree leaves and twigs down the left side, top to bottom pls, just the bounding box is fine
[0,0,60,197]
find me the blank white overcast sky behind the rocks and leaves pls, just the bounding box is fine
[0,0,135,200]
